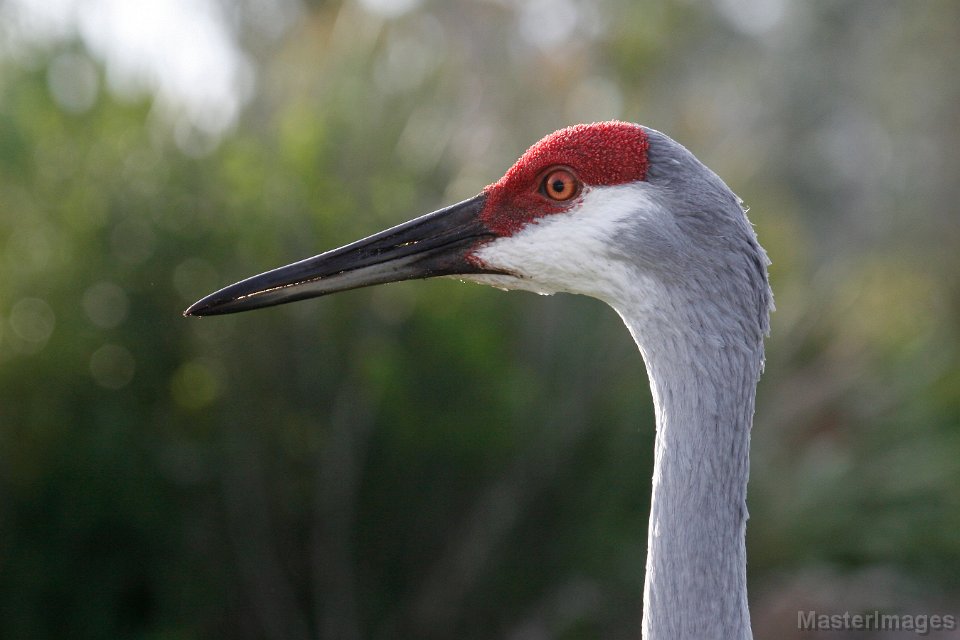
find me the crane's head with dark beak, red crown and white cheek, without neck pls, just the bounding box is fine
[184,121,765,324]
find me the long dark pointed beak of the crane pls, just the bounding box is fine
[183,193,495,316]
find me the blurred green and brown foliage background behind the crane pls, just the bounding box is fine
[0,0,960,639]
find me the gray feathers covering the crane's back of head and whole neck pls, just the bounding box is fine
[609,130,772,640]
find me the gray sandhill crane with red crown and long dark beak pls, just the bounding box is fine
[185,122,772,640]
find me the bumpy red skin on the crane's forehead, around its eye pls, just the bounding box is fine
[480,121,648,236]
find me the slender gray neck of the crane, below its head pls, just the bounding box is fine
[619,309,763,640]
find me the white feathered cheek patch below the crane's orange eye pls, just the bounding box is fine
[460,183,663,302]
